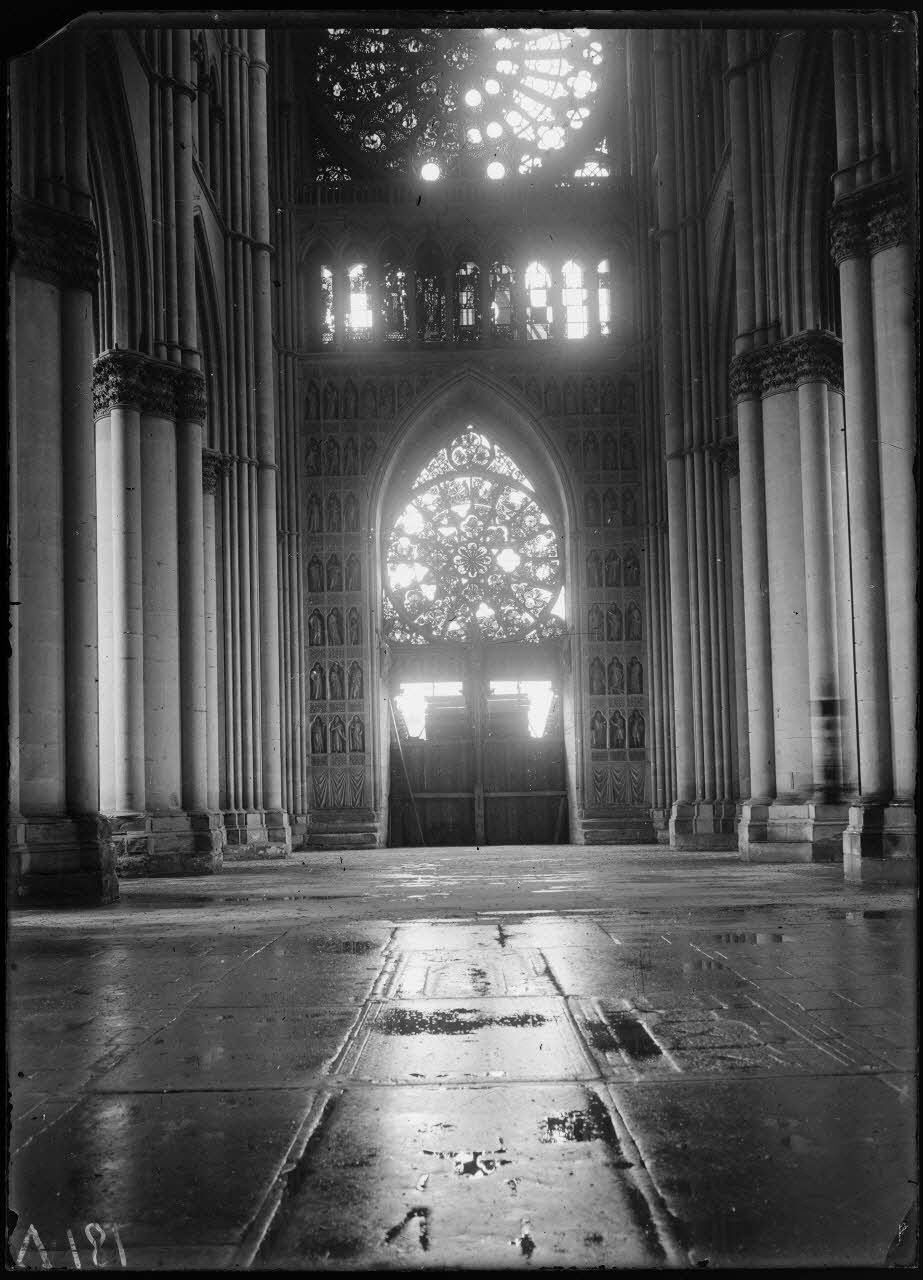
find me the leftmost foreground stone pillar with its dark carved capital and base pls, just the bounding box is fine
[9,194,118,906]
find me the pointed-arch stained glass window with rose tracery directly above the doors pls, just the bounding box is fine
[385,426,563,644]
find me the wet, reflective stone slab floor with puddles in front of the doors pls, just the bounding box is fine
[8,846,918,1271]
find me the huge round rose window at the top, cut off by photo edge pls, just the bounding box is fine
[312,27,606,182]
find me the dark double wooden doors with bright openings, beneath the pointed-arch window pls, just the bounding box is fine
[389,643,568,846]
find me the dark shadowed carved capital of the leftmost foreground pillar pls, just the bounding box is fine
[13,196,99,293]
